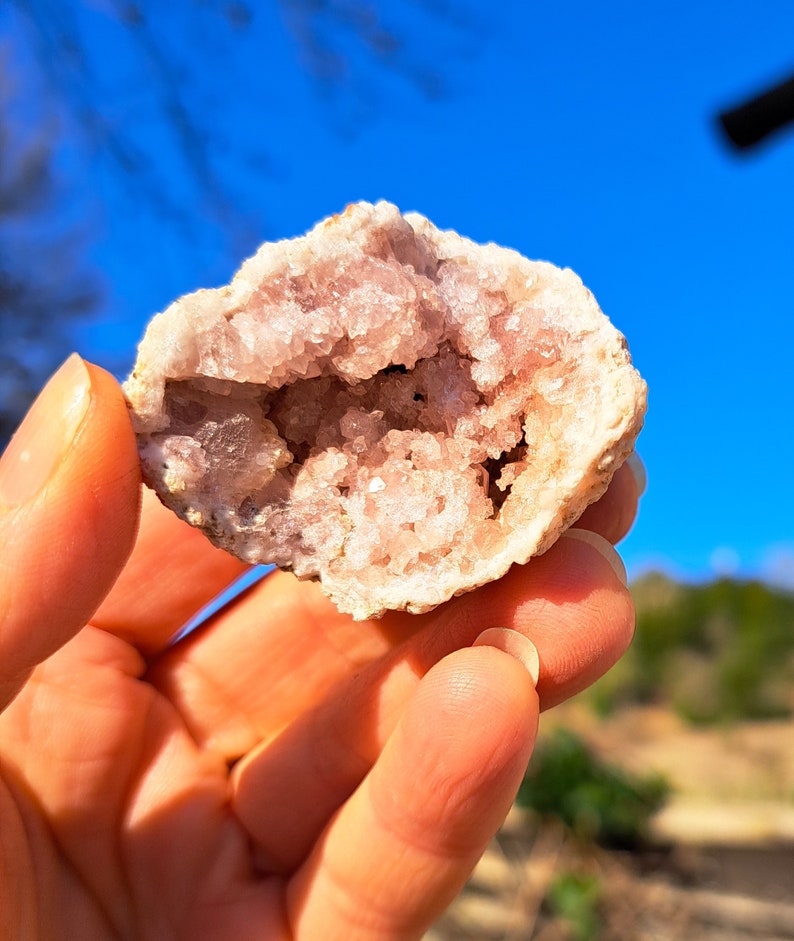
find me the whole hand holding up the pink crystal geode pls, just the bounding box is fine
[0,357,638,941]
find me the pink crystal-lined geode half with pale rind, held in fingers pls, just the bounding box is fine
[125,202,646,619]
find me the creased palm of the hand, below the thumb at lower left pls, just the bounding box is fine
[0,628,255,939]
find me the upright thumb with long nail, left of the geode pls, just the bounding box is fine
[0,354,140,709]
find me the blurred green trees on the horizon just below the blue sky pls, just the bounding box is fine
[586,573,794,724]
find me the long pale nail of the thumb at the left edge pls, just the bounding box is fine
[0,353,91,507]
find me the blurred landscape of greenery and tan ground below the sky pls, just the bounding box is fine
[508,572,794,941]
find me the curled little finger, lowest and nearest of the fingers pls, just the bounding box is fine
[288,631,538,941]
